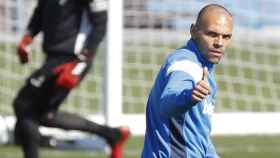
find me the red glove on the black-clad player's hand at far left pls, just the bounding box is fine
[17,34,32,64]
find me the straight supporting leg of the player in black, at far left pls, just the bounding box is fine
[13,73,46,158]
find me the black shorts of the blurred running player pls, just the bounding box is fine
[13,56,90,119]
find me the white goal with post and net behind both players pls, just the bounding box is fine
[0,0,280,138]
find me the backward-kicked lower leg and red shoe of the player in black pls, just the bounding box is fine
[41,112,129,158]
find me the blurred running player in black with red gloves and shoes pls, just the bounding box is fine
[13,0,129,158]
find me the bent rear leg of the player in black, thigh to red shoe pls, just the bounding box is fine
[40,59,129,158]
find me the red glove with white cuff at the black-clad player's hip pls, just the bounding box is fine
[54,61,86,90]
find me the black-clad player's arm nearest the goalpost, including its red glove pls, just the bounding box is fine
[50,0,107,90]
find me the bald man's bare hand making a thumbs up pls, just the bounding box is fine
[192,67,211,102]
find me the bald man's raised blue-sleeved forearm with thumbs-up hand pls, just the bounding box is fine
[160,67,210,117]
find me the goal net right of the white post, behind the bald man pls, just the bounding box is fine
[120,0,280,134]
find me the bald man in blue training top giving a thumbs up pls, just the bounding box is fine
[142,4,233,158]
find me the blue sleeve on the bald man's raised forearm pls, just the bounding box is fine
[160,71,195,117]
